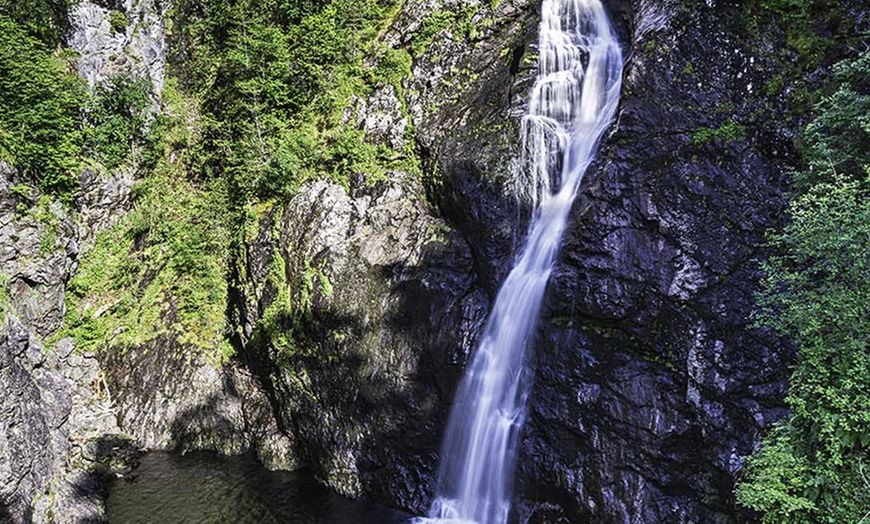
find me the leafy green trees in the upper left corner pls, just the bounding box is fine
[0,9,150,202]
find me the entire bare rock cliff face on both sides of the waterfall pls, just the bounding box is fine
[0,0,860,522]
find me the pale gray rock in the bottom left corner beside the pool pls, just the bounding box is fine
[0,314,126,524]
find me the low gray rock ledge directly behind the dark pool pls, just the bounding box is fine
[100,335,297,469]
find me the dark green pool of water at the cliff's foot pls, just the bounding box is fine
[106,452,409,524]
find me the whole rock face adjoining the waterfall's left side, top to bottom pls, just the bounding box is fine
[228,2,536,513]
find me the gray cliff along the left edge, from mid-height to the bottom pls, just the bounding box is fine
[0,166,133,523]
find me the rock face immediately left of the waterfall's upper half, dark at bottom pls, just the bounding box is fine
[404,0,539,295]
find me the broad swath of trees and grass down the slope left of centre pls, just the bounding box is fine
[49,0,428,360]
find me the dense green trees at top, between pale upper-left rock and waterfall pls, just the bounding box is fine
[175,0,410,204]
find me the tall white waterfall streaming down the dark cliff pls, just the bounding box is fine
[429,0,622,524]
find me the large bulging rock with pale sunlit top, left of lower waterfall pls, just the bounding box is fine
[233,172,487,511]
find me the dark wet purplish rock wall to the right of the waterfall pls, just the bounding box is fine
[510,2,836,522]
